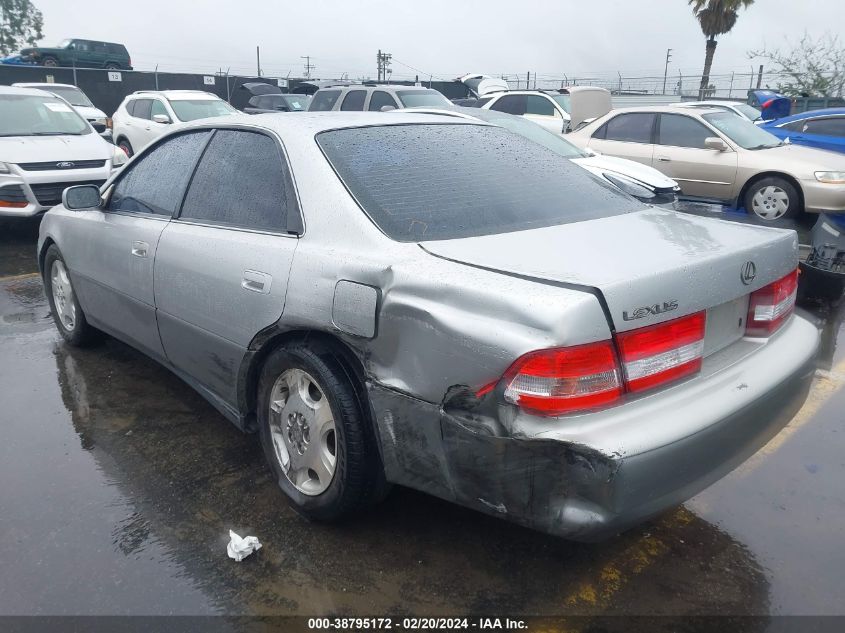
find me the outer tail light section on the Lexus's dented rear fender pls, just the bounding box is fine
[503,341,622,416]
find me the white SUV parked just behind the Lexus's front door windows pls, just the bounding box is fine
[112,90,240,156]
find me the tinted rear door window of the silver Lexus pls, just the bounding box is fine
[180,130,293,231]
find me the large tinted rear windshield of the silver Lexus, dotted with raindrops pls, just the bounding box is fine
[317,124,643,242]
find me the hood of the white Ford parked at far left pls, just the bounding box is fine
[0,132,114,163]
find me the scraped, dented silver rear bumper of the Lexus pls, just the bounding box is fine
[369,317,819,541]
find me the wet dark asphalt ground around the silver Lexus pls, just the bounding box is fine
[0,215,845,630]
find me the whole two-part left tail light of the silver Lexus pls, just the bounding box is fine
[494,312,706,416]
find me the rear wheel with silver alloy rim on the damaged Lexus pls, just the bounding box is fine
[257,342,385,521]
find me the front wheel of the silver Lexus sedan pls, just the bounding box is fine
[44,244,102,347]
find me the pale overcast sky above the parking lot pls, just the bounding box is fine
[33,0,845,79]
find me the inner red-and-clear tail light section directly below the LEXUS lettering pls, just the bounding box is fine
[616,312,706,392]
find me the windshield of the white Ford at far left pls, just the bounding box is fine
[0,95,91,136]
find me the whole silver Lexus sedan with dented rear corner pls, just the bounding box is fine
[38,113,819,540]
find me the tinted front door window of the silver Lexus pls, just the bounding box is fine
[109,131,211,215]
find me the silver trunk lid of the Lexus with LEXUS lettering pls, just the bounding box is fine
[421,207,798,331]
